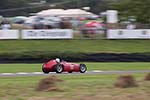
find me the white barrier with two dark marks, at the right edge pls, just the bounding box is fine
[107,29,150,39]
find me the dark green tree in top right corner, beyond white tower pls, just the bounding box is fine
[112,0,150,23]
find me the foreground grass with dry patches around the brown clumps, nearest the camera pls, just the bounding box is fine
[0,74,150,100]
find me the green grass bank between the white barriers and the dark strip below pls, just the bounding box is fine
[0,40,150,54]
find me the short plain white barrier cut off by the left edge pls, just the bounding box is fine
[0,30,19,39]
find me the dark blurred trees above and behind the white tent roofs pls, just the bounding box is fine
[0,0,109,16]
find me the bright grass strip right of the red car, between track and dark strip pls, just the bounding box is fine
[86,62,150,70]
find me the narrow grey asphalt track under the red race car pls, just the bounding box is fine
[0,70,150,76]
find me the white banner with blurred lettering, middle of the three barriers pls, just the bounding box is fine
[22,29,73,39]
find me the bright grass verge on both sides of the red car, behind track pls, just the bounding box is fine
[0,62,150,73]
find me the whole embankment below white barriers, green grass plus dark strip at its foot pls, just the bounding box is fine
[0,40,150,63]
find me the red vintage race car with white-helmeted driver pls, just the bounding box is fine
[42,58,87,74]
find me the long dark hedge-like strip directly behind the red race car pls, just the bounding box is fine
[0,51,150,63]
